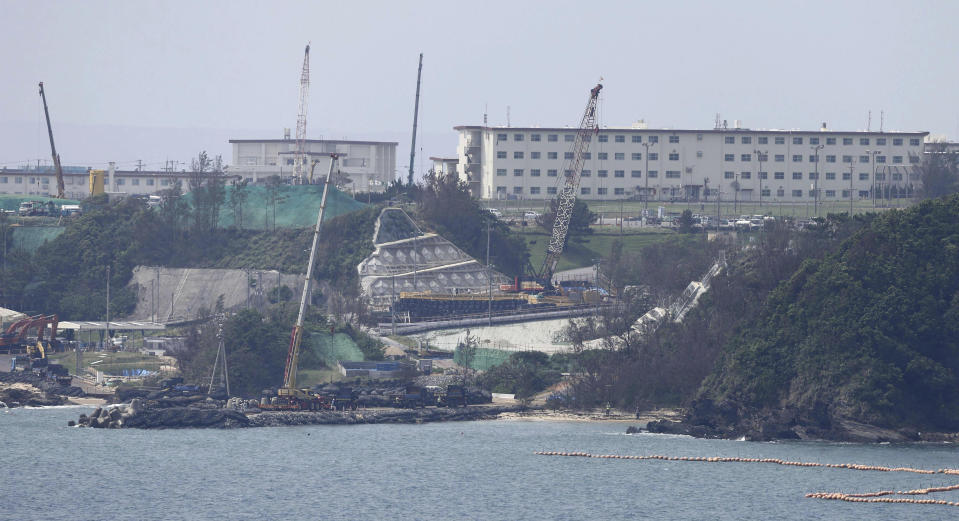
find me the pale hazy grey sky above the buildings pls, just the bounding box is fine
[0,0,959,177]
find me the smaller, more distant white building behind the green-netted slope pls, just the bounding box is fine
[229,139,398,193]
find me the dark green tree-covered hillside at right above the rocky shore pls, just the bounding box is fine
[699,196,959,430]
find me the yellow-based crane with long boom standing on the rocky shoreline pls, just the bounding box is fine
[261,154,339,410]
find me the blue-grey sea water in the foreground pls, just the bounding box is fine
[0,407,959,521]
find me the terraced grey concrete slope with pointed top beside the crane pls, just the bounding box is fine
[357,208,509,310]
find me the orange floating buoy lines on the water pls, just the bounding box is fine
[533,451,959,507]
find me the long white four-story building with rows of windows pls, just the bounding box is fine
[454,125,928,203]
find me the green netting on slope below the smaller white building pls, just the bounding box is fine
[183,185,366,230]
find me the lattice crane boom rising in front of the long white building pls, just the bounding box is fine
[540,83,603,286]
